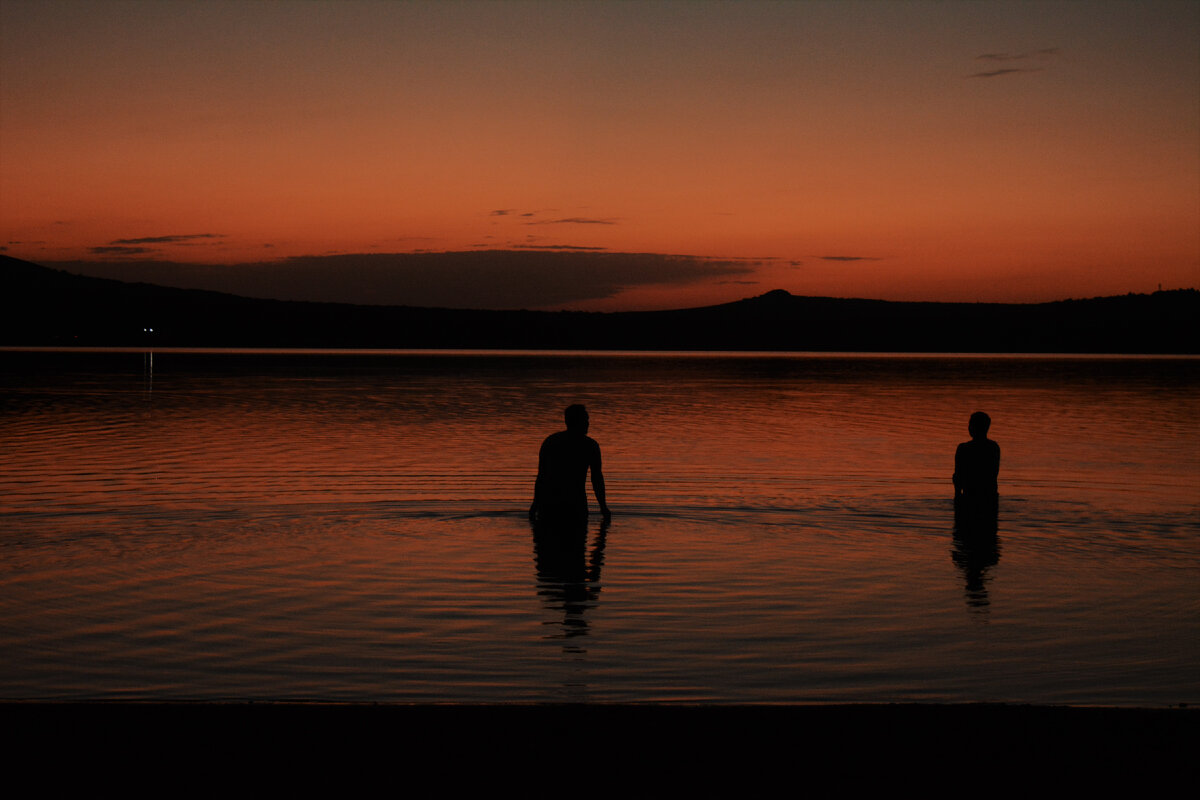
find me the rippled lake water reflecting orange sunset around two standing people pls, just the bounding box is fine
[0,351,1200,705]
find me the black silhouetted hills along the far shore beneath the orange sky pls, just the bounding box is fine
[0,255,1200,354]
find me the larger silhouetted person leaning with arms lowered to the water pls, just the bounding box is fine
[529,403,611,522]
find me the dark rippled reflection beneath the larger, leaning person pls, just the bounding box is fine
[530,517,610,652]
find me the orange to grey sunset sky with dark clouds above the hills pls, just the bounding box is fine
[0,0,1200,309]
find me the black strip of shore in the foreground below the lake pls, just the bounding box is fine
[0,702,1200,796]
